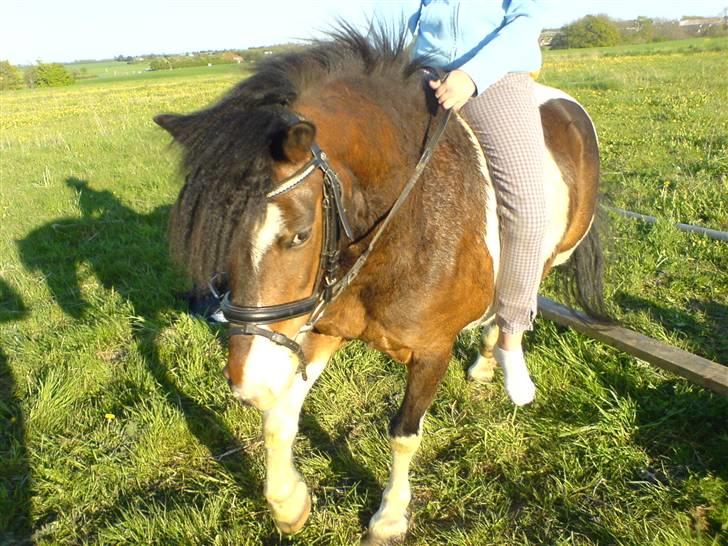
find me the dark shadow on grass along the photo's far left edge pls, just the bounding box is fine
[0,279,32,545]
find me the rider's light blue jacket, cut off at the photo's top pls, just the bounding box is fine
[408,0,544,94]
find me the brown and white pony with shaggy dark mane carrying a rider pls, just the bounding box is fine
[156,28,601,543]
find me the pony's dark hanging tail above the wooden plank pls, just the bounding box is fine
[559,214,613,322]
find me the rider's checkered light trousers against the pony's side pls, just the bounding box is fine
[461,73,546,333]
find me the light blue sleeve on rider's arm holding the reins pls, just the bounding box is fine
[460,0,544,95]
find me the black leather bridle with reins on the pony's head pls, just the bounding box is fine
[209,106,450,381]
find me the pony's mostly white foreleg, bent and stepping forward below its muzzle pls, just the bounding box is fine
[263,336,341,534]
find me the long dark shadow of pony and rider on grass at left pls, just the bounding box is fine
[16,178,260,537]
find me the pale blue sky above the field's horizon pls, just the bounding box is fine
[0,0,728,64]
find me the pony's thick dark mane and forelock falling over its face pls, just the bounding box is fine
[169,24,419,288]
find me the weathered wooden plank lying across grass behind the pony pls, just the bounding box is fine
[538,296,728,396]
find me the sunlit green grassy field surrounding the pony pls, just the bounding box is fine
[0,39,728,545]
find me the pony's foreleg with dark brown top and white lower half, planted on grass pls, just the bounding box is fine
[362,354,449,546]
